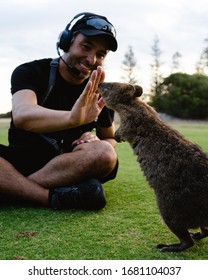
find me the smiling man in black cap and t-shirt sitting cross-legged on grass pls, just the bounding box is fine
[0,13,118,210]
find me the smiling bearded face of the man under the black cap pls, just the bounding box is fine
[66,33,109,82]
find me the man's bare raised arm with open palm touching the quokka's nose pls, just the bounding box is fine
[12,67,104,133]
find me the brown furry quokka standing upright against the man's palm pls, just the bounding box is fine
[99,83,208,251]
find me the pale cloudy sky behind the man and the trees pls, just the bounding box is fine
[0,0,208,113]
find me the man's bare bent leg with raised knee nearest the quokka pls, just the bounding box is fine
[28,141,117,188]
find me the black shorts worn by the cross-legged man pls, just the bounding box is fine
[0,140,118,183]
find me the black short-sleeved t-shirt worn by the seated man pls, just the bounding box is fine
[9,58,114,151]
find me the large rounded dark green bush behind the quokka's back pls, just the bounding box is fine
[150,73,208,119]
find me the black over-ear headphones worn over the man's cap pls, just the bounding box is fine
[56,13,103,52]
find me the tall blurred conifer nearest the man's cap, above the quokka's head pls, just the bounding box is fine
[122,46,138,85]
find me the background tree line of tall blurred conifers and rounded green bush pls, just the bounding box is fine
[122,36,208,119]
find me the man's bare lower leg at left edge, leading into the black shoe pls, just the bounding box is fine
[0,157,49,206]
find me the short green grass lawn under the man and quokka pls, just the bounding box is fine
[0,119,208,260]
